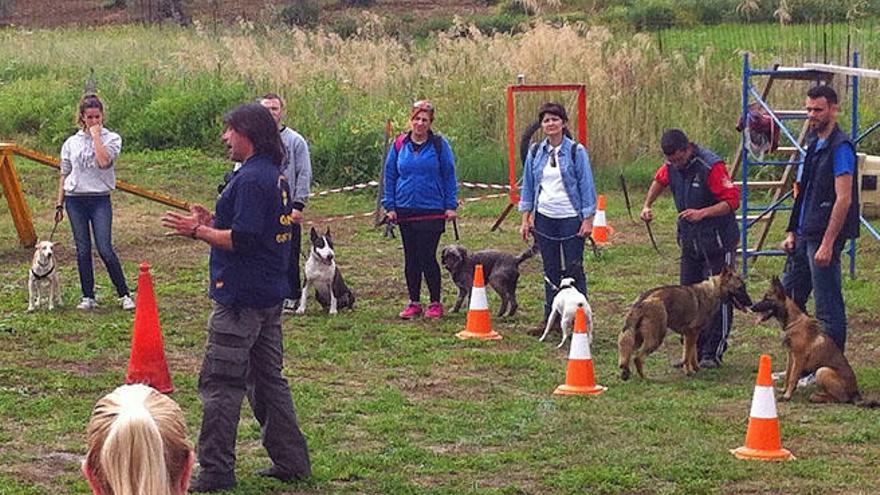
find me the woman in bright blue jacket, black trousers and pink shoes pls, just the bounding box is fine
[382,100,458,319]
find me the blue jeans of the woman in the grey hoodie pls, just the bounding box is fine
[64,195,128,299]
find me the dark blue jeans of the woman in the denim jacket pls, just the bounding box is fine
[535,212,587,320]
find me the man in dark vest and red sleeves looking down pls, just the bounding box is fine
[640,129,740,368]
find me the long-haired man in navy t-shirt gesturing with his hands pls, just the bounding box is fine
[162,103,311,492]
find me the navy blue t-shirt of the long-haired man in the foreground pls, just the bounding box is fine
[209,155,293,308]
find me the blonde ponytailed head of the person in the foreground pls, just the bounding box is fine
[83,385,193,495]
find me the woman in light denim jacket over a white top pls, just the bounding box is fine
[519,102,596,321]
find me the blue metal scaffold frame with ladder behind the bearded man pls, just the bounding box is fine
[740,52,880,277]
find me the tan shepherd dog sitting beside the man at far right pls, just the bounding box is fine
[752,277,880,407]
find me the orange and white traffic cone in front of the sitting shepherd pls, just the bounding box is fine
[730,354,794,461]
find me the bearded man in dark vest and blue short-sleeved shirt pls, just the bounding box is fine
[782,86,859,351]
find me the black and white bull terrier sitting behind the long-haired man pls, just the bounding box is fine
[296,227,354,315]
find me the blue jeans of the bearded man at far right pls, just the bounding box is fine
[782,239,846,352]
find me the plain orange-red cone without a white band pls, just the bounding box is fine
[125,262,174,394]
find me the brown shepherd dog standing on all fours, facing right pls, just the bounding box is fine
[617,266,752,380]
